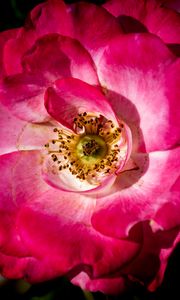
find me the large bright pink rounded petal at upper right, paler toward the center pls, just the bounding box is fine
[98,34,180,151]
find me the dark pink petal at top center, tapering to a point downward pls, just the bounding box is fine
[68,2,122,58]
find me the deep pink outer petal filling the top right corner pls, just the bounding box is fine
[104,0,180,44]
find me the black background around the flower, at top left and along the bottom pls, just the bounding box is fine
[0,0,180,300]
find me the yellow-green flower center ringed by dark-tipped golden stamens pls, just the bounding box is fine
[45,112,125,184]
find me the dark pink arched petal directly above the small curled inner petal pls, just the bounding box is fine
[22,34,98,85]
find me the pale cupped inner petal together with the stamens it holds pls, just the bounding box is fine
[43,112,131,191]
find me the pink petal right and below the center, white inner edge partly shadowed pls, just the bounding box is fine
[92,149,180,237]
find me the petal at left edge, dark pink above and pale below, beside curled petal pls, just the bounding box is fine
[0,74,50,123]
